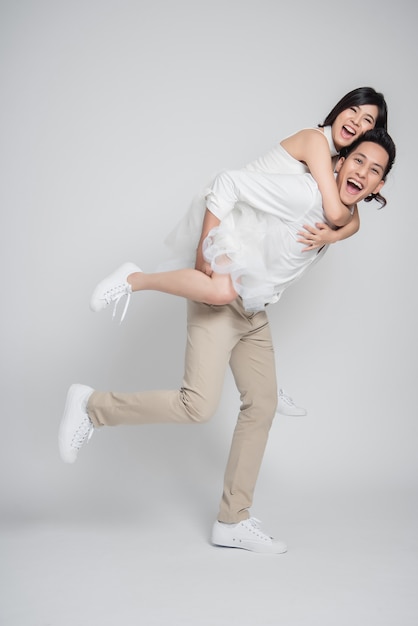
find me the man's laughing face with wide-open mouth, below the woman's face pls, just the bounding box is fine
[335,141,389,206]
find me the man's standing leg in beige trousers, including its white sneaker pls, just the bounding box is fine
[212,302,287,554]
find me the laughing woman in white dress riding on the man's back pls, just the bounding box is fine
[91,87,387,312]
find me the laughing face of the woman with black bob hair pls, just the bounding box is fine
[332,104,379,151]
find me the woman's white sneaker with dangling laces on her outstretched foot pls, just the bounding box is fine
[90,263,142,322]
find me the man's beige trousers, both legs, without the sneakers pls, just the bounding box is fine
[87,298,277,523]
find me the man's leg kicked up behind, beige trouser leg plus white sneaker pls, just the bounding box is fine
[59,302,242,463]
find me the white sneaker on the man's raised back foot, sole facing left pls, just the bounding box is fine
[58,385,94,463]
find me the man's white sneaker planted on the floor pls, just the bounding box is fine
[212,517,287,554]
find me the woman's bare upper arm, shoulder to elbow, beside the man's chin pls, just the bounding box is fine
[281,129,352,227]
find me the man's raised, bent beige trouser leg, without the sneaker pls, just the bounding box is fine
[87,301,245,426]
